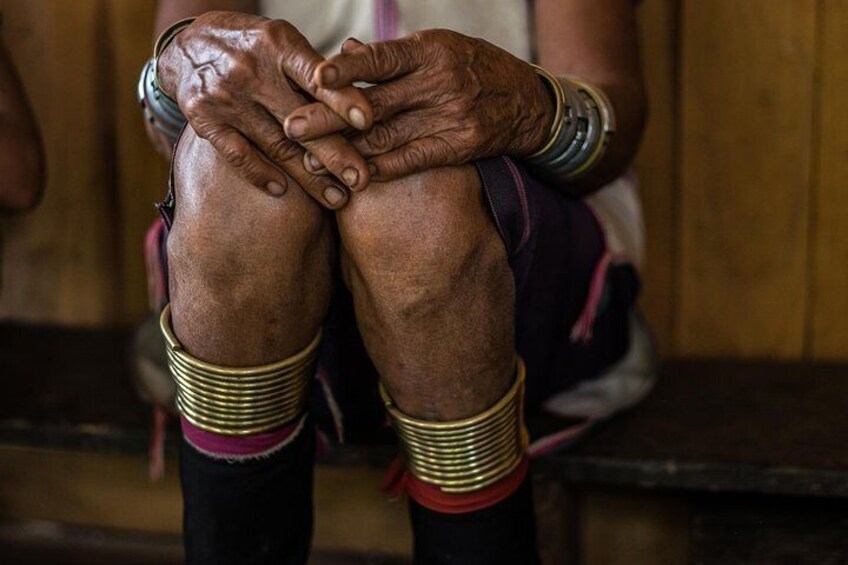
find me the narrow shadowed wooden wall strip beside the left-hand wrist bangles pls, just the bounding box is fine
[108,0,168,321]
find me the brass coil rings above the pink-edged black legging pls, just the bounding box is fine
[159,304,321,436]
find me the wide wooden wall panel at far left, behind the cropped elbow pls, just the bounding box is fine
[0,0,120,324]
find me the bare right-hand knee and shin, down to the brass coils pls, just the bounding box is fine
[337,166,515,420]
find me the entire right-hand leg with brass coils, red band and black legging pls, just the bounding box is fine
[337,166,537,564]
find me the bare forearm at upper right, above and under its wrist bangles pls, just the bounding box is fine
[535,0,647,194]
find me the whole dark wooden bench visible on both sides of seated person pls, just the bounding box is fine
[0,324,848,565]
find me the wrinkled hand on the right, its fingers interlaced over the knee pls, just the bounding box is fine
[285,30,554,180]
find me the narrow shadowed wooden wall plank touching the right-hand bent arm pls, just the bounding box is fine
[636,0,677,353]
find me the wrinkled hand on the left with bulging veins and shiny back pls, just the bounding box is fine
[159,12,372,208]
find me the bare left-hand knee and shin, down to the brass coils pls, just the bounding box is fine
[168,130,334,363]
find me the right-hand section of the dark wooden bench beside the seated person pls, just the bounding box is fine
[535,360,848,565]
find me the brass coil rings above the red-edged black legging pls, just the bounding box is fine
[380,358,528,494]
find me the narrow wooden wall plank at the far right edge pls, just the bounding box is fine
[812,0,848,360]
